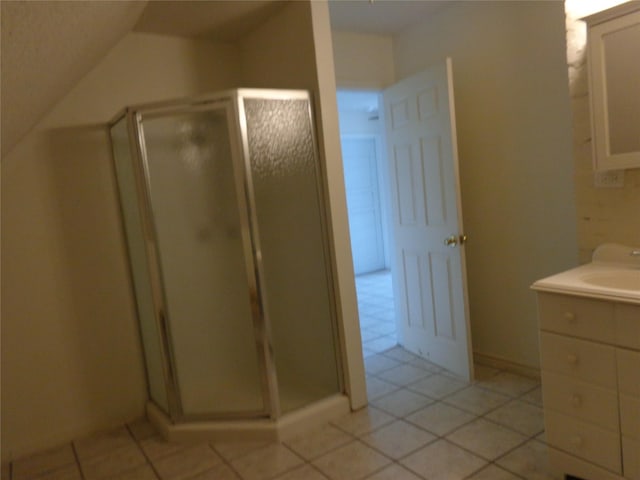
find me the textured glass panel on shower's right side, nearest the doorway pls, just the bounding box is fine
[244,97,340,413]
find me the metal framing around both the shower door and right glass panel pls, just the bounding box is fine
[109,89,345,422]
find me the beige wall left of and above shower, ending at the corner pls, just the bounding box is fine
[2,34,239,460]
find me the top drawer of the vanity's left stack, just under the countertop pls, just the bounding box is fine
[538,293,616,343]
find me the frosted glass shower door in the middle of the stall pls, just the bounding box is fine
[139,103,266,417]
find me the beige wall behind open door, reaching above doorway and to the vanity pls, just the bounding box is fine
[394,1,577,367]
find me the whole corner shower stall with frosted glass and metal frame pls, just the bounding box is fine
[110,89,348,439]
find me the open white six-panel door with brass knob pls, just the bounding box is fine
[384,59,473,380]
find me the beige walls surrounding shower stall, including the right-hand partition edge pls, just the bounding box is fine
[2,2,366,461]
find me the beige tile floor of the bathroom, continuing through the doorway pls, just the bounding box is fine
[2,270,556,480]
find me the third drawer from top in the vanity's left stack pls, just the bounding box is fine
[542,370,619,431]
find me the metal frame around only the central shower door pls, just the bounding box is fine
[114,93,279,422]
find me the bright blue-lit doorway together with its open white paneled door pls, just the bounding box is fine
[338,62,473,380]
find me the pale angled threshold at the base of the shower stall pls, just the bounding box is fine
[147,394,350,442]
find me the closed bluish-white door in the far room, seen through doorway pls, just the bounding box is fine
[341,135,385,275]
